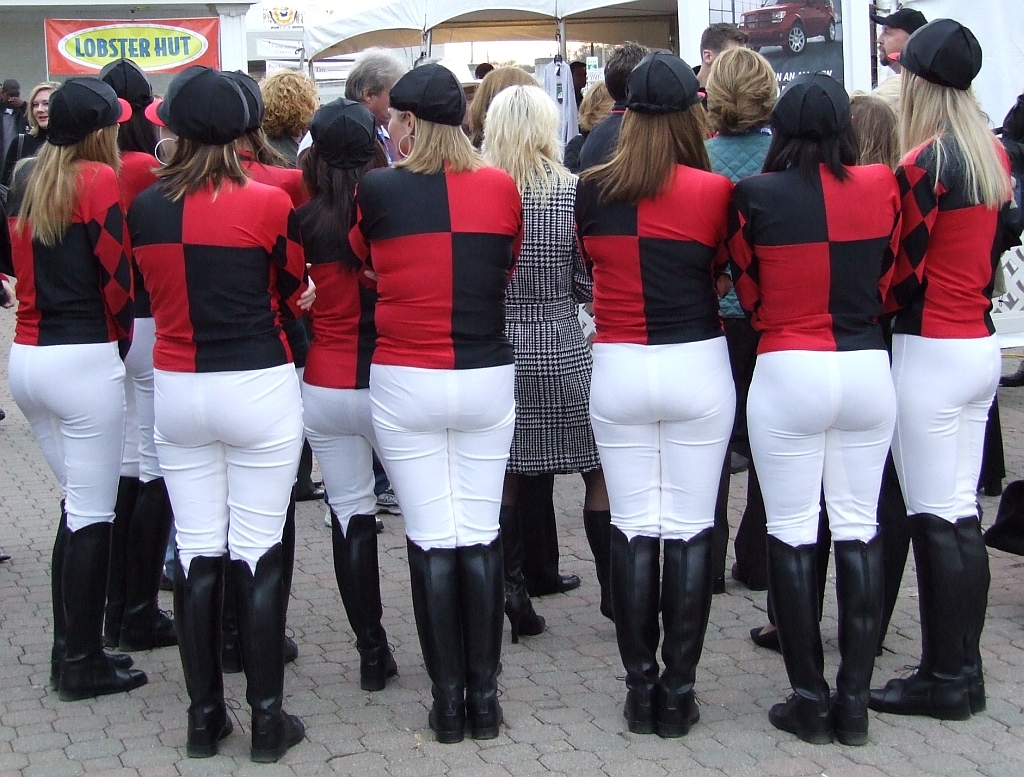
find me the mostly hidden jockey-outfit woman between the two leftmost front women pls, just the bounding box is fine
[99,54,177,651]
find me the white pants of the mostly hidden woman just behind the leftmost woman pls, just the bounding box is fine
[121,318,162,483]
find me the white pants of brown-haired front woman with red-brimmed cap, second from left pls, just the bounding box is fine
[154,363,302,573]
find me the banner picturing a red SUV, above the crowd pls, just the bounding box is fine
[709,0,845,86]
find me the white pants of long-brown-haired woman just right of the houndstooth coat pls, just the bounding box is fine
[590,337,736,541]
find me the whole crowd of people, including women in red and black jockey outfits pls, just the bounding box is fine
[0,11,1014,762]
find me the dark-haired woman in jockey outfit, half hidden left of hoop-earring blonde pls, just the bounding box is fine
[298,98,398,691]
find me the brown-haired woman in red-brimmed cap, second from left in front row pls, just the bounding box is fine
[128,67,313,762]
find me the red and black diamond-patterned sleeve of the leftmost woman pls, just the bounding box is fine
[79,165,135,353]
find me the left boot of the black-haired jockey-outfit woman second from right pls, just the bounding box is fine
[768,534,831,744]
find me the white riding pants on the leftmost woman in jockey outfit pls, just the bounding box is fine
[7,343,125,531]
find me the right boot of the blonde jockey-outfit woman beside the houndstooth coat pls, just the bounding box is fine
[456,536,505,739]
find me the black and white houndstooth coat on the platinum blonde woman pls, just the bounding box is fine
[505,171,600,475]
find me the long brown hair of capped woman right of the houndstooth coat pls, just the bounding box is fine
[583,103,711,205]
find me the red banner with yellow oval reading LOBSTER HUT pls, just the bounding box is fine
[45,18,220,76]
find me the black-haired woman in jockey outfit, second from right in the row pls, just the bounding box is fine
[729,74,900,744]
